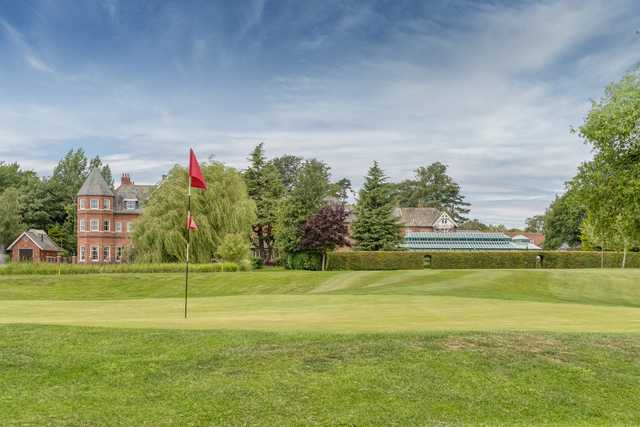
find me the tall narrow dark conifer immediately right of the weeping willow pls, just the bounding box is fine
[243,143,285,264]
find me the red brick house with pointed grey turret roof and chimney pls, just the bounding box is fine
[76,169,155,263]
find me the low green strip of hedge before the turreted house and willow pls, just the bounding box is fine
[0,262,240,275]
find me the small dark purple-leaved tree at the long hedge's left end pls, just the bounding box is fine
[300,203,349,270]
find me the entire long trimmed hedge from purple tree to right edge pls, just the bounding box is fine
[327,251,640,270]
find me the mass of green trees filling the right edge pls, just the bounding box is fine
[544,69,640,266]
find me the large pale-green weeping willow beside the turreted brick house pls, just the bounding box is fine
[133,162,256,263]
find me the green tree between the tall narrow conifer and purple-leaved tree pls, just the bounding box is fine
[275,159,330,256]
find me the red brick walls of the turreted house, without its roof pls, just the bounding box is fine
[76,196,138,263]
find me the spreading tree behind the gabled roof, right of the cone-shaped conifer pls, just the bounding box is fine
[397,162,469,222]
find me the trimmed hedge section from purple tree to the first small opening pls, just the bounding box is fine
[327,251,424,270]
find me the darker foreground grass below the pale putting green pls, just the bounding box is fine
[0,326,640,426]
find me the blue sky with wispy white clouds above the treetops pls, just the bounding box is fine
[0,0,640,226]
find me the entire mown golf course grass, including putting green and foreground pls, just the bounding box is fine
[0,270,640,426]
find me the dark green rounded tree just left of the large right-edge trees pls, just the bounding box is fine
[544,190,586,249]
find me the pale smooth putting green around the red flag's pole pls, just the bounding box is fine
[0,295,640,333]
